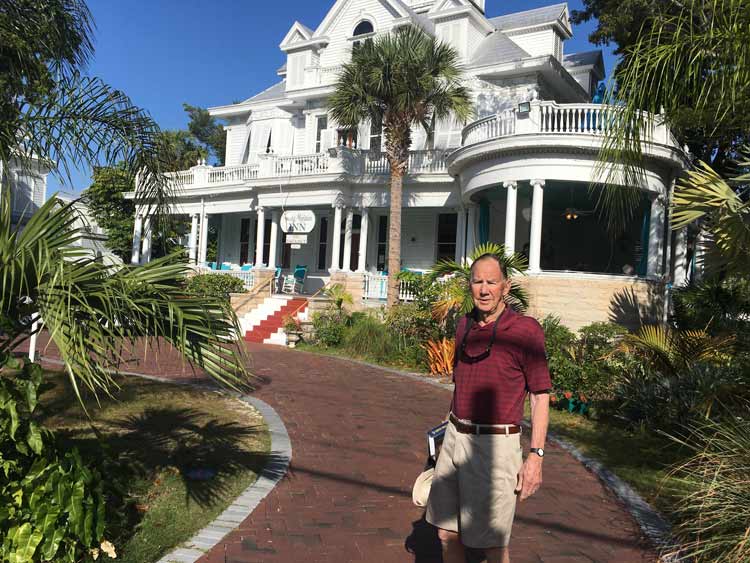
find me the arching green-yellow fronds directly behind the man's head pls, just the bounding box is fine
[430,242,529,320]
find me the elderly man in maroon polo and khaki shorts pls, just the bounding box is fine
[427,254,552,563]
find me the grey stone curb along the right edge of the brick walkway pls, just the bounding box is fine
[290,350,680,563]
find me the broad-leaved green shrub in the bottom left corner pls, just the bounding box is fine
[0,361,116,563]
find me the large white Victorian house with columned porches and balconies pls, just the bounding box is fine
[128,0,687,328]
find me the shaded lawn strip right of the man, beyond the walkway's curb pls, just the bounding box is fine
[540,406,687,518]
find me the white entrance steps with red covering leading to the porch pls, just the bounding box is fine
[240,295,307,346]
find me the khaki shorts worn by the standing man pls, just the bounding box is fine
[426,422,523,549]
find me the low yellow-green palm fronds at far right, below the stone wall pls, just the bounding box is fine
[618,325,734,377]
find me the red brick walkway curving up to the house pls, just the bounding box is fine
[26,345,655,563]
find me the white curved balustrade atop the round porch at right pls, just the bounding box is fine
[461,102,677,146]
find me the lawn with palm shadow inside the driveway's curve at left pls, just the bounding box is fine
[39,374,270,563]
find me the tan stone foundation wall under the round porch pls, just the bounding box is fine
[517,273,664,330]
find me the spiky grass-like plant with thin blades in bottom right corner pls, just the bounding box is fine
[671,410,750,563]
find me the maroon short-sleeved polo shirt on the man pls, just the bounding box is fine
[452,307,552,424]
